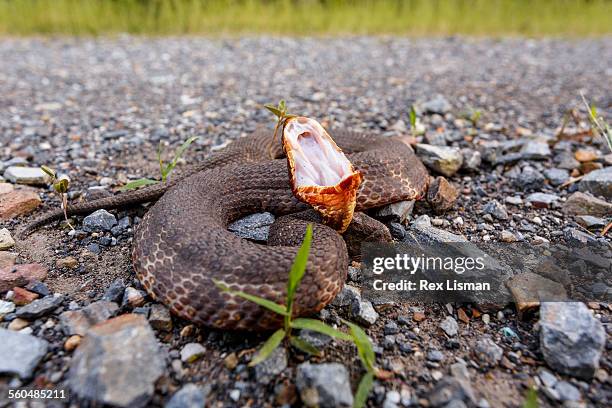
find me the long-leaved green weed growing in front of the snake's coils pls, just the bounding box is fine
[214,224,382,408]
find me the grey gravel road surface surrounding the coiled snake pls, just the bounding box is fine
[0,37,612,408]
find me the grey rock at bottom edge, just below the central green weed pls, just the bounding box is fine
[295,363,353,408]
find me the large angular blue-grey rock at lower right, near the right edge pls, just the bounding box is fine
[540,302,606,380]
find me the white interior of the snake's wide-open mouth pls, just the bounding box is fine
[284,117,352,187]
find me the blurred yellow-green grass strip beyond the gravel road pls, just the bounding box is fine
[0,0,612,37]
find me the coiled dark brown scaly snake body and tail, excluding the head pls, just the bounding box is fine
[27,129,428,330]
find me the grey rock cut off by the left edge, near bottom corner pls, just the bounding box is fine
[0,329,48,378]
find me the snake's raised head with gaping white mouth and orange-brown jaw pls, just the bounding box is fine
[282,116,363,233]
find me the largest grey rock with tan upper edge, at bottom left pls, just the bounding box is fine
[68,314,165,407]
